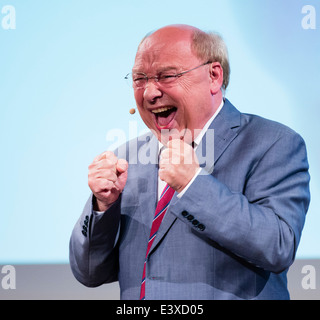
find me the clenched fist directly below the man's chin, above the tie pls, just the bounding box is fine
[159,139,199,193]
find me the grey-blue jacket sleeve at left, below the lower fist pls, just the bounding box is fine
[69,195,120,287]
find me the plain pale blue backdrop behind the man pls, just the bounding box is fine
[0,0,320,264]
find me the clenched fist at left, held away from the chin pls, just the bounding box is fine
[88,151,128,211]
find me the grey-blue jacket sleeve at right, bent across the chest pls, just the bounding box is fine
[171,133,310,273]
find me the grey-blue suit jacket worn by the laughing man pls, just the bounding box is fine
[70,100,310,300]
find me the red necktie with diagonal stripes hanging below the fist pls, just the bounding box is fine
[140,184,174,300]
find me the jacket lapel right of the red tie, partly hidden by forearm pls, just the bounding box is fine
[148,99,241,254]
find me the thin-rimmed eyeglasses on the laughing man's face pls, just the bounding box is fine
[124,61,212,89]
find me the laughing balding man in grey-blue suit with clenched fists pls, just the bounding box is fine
[70,25,309,299]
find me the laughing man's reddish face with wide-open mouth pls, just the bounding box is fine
[133,30,214,143]
